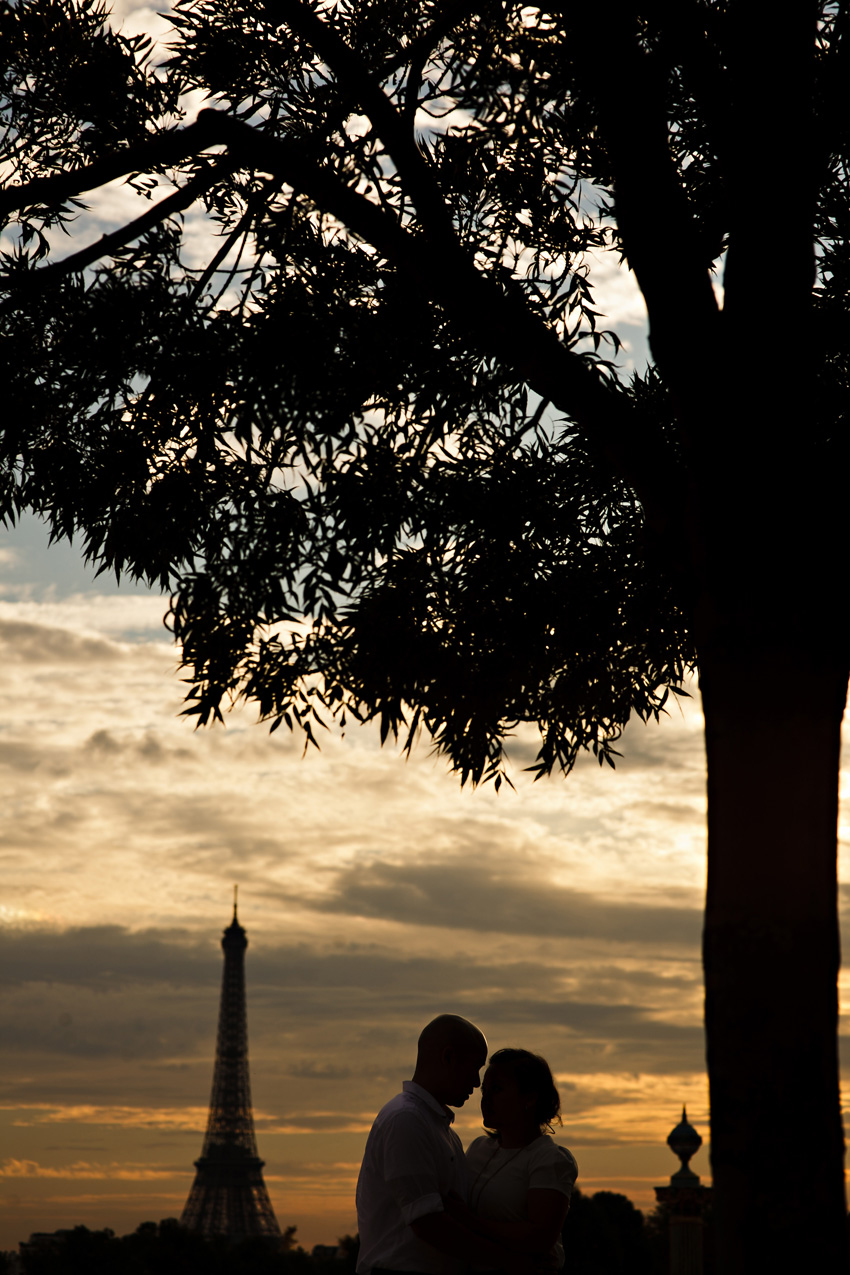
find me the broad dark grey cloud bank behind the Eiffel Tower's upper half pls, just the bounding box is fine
[0,926,702,1100]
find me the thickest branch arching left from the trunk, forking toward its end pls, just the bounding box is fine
[4,92,673,519]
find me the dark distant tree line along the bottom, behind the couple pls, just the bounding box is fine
[0,1190,714,1275]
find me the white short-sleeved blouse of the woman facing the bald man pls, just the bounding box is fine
[466,1133,579,1265]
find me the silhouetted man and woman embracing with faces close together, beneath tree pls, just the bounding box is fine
[357,1014,579,1275]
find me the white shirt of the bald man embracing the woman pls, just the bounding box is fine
[357,1080,466,1275]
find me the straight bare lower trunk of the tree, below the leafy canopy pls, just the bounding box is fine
[700,647,849,1275]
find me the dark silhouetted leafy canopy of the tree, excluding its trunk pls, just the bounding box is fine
[3,0,717,782]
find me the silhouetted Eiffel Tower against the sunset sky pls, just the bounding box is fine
[180,890,280,1239]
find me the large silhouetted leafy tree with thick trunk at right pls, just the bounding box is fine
[0,0,850,1275]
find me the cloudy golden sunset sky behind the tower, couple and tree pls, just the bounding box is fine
[0,4,850,1248]
